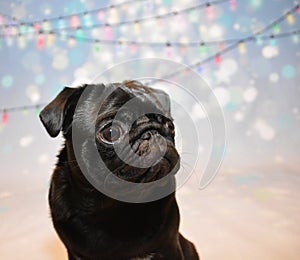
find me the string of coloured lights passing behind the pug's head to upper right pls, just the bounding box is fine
[0,4,300,122]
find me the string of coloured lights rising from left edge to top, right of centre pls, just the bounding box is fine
[2,0,229,34]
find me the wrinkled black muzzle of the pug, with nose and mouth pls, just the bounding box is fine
[113,128,180,183]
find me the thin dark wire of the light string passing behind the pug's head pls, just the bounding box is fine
[0,4,300,116]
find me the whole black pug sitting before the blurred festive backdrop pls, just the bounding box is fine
[40,81,199,260]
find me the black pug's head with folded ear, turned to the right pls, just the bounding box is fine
[40,81,179,187]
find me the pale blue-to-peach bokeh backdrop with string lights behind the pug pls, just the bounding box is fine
[0,0,300,260]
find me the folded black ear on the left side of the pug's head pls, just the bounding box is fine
[40,87,78,137]
